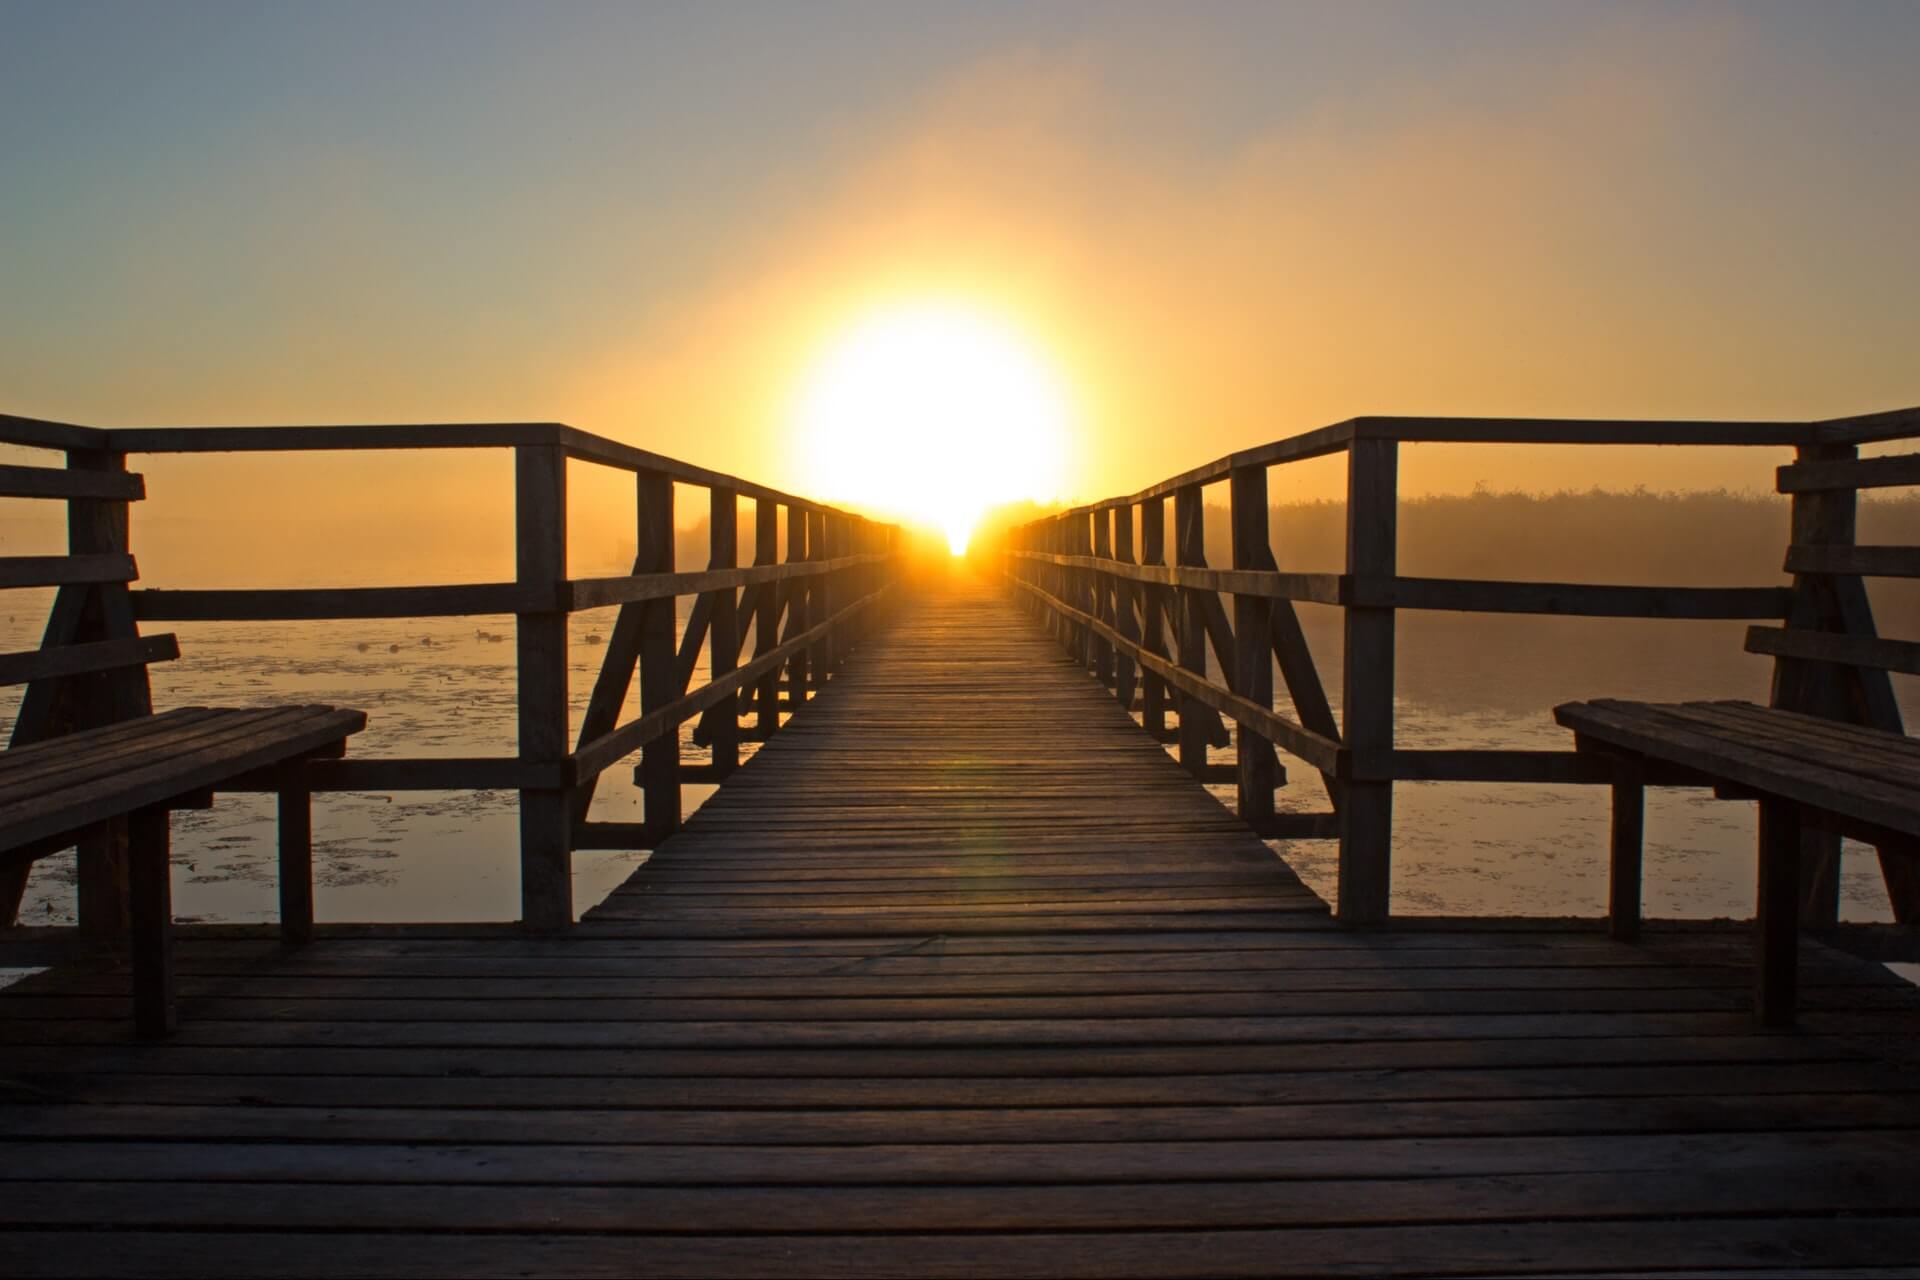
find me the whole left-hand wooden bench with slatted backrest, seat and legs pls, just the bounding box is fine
[0,435,367,1036]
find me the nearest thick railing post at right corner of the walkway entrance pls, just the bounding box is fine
[1336,438,1400,925]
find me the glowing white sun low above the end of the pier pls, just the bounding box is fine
[793,301,1069,555]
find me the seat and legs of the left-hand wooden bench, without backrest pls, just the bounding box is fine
[0,706,367,1038]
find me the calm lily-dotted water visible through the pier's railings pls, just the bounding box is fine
[0,593,1912,923]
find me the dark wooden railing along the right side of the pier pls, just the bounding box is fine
[1006,409,1920,925]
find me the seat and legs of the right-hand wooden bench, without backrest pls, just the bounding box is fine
[1553,699,1920,1027]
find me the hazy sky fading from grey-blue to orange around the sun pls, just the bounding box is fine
[0,0,1920,556]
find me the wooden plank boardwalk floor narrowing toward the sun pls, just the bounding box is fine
[0,583,1920,1276]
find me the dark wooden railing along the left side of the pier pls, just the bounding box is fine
[0,415,900,929]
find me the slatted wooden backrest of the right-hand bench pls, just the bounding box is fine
[1747,445,1920,733]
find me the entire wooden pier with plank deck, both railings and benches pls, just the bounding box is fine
[0,411,1920,1278]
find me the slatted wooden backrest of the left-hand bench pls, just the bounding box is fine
[0,415,180,747]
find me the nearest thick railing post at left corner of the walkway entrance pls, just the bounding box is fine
[513,445,574,931]
